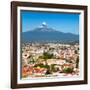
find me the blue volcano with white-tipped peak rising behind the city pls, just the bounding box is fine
[21,23,79,43]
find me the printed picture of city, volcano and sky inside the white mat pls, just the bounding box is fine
[21,10,80,79]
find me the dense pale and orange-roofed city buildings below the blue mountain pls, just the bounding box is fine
[22,43,80,76]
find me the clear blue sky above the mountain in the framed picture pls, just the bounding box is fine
[21,11,79,34]
